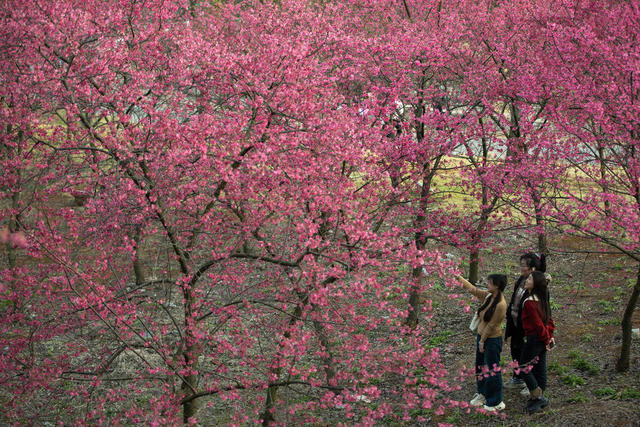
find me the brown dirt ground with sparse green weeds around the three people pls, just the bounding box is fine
[430,238,640,426]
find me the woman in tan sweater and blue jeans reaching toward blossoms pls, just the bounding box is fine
[457,274,507,412]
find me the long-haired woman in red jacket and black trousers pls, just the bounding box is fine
[520,271,555,414]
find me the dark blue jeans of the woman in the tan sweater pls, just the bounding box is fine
[476,334,502,406]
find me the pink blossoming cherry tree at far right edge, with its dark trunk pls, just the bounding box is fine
[536,1,640,371]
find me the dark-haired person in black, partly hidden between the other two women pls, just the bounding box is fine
[504,252,547,396]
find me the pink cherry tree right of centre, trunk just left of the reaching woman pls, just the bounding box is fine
[332,1,478,327]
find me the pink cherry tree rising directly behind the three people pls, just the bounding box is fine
[456,2,562,260]
